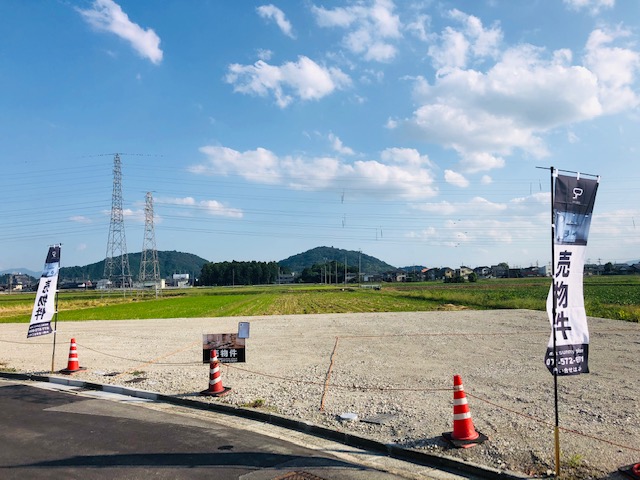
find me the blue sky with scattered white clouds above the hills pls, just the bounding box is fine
[0,0,640,273]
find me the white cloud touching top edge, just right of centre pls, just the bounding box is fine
[311,0,402,62]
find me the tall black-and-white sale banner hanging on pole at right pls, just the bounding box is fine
[545,175,598,375]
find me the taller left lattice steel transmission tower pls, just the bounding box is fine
[104,153,132,289]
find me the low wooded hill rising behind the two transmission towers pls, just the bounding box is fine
[58,250,209,282]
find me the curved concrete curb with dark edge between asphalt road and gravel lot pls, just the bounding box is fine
[0,372,532,480]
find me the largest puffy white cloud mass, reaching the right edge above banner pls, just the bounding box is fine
[396,10,640,173]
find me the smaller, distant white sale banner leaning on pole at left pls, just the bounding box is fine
[27,245,60,338]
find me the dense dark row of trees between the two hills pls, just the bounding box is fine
[199,260,279,286]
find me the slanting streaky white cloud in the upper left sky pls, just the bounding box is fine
[78,0,163,65]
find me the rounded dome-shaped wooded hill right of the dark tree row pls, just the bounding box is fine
[278,247,397,274]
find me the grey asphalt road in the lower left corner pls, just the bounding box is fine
[0,381,468,480]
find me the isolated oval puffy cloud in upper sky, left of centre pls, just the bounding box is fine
[225,56,351,108]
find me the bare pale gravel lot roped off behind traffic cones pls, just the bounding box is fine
[0,310,640,479]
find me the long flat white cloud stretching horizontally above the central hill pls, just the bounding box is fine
[189,146,436,199]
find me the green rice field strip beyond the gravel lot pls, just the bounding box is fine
[0,275,640,323]
